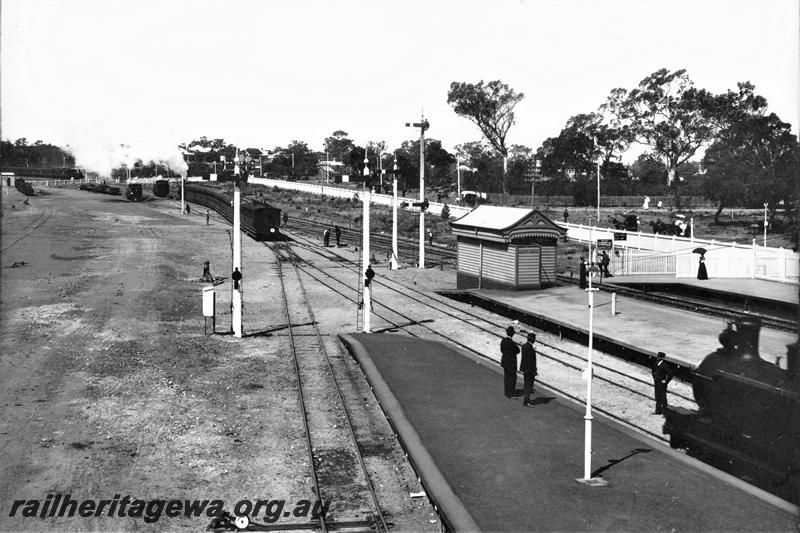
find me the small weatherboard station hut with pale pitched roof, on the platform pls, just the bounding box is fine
[451,205,566,290]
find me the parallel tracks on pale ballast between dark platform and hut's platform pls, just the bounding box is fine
[268,231,694,442]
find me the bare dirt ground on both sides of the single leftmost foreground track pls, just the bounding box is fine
[0,188,440,531]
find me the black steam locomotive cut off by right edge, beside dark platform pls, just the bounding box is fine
[664,316,800,502]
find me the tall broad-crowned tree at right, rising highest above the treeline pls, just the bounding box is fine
[601,69,718,207]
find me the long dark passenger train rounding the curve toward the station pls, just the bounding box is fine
[184,183,284,241]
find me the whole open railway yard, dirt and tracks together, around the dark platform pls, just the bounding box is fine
[0,188,796,531]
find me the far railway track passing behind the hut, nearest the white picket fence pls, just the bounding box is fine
[288,215,797,331]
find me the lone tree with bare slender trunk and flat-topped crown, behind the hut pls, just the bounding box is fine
[447,80,525,194]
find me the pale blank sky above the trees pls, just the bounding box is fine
[0,0,800,169]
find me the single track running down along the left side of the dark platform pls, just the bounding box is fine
[269,243,390,533]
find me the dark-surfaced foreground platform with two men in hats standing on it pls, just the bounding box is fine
[340,333,798,531]
